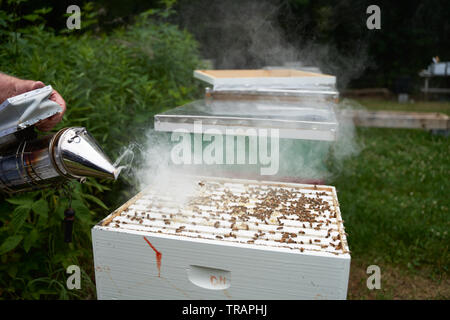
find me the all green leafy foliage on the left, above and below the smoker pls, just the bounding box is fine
[0,1,199,299]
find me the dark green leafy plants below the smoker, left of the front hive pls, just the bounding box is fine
[0,184,104,299]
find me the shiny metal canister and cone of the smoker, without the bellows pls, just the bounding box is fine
[0,127,117,193]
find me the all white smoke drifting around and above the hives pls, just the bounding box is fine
[118,0,368,192]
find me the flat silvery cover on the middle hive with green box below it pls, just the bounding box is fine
[155,100,338,141]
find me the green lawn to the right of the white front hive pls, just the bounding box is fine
[330,128,450,276]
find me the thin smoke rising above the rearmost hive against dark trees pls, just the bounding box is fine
[179,0,371,89]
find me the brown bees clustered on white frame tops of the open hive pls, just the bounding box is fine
[107,181,344,252]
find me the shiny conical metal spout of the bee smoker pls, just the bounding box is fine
[50,127,119,179]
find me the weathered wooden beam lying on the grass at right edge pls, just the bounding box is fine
[340,110,450,130]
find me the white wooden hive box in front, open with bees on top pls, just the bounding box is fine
[92,177,350,299]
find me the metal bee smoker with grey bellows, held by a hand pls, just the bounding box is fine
[0,86,119,242]
